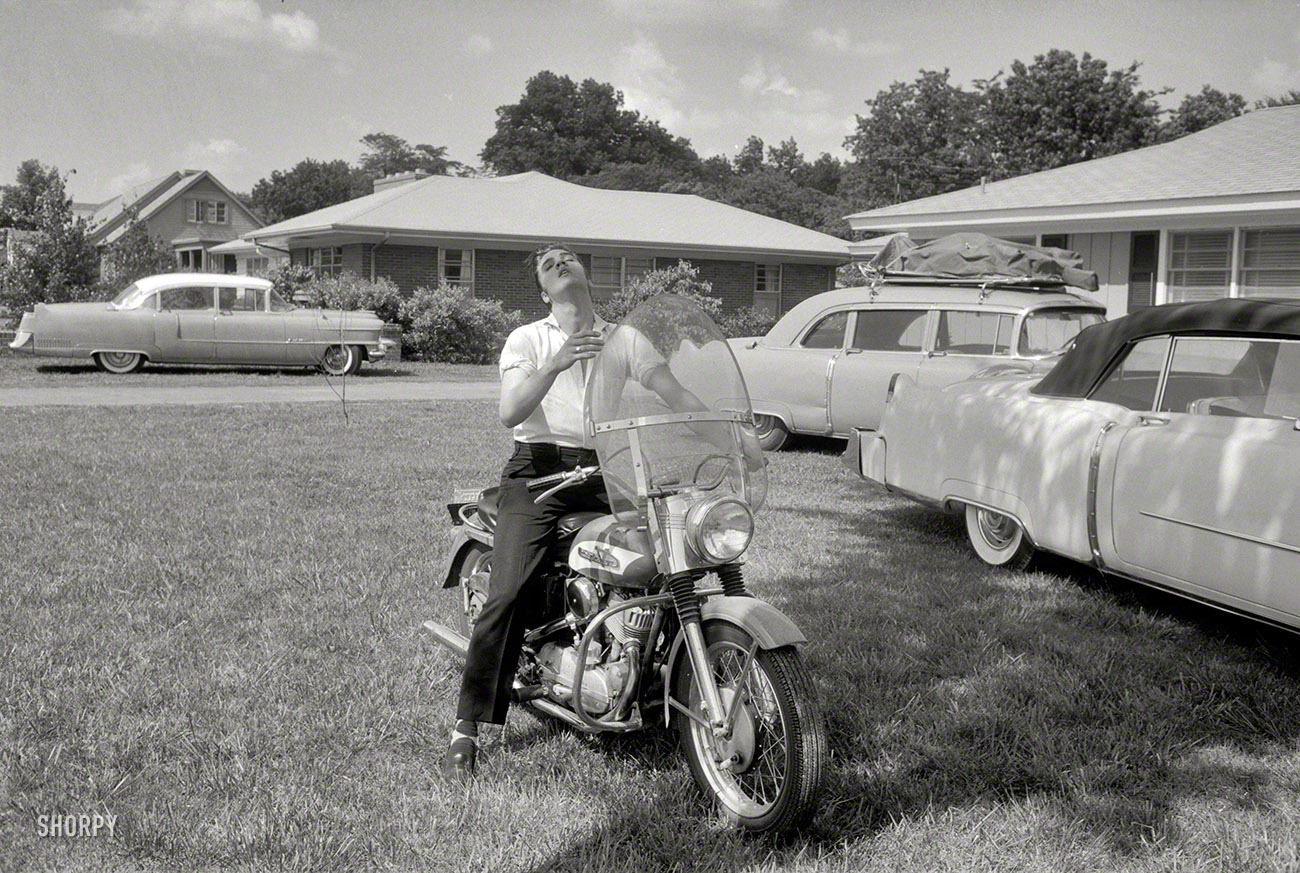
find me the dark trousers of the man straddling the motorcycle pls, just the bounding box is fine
[456,443,610,725]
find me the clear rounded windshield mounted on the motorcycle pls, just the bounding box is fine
[586,294,767,512]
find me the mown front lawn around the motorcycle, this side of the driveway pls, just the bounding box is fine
[0,403,1300,872]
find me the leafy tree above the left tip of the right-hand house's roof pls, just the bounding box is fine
[840,70,983,209]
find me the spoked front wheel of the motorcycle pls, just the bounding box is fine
[673,621,826,831]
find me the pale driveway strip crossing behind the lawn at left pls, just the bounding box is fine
[0,379,501,407]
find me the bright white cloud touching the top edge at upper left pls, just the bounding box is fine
[103,0,329,55]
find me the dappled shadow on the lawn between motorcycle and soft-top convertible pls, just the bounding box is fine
[517,493,1300,873]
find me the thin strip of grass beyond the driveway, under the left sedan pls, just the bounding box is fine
[0,347,497,388]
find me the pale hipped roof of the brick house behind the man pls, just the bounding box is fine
[244,173,849,261]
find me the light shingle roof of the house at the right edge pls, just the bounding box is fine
[849,105,1300,220]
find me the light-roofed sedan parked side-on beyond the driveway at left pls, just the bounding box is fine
[9,273,394,375]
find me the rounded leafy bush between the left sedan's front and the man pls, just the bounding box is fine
[398,282,524,364]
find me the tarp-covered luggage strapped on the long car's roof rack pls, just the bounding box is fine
[866,234,1100,291]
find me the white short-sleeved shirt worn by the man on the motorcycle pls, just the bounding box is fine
[501,316,664,448]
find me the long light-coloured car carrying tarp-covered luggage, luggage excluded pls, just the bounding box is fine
[731,285,1106,451]
